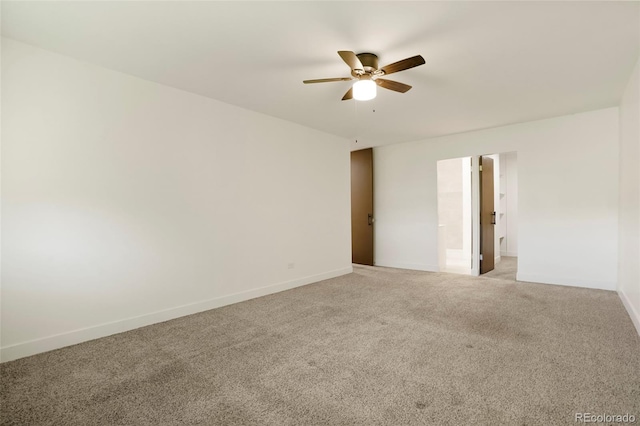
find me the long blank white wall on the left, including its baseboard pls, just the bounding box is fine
[1,40,351,360]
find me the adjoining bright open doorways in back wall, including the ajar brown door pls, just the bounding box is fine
[437,152,518,281]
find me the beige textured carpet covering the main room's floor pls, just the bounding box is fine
[0,267,640,425]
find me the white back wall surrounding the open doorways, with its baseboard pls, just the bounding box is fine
[374,107,618,290]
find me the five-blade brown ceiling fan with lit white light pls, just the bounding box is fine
[303,50,425,101]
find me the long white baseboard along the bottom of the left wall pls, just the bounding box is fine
[0,266,353,362]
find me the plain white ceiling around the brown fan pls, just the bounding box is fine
[2,1,640,147]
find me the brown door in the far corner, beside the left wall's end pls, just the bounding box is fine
[351,148,373,265]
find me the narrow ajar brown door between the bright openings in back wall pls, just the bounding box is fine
[480,157,496,274]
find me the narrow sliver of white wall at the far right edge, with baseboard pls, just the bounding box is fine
[618,57,640,333]
